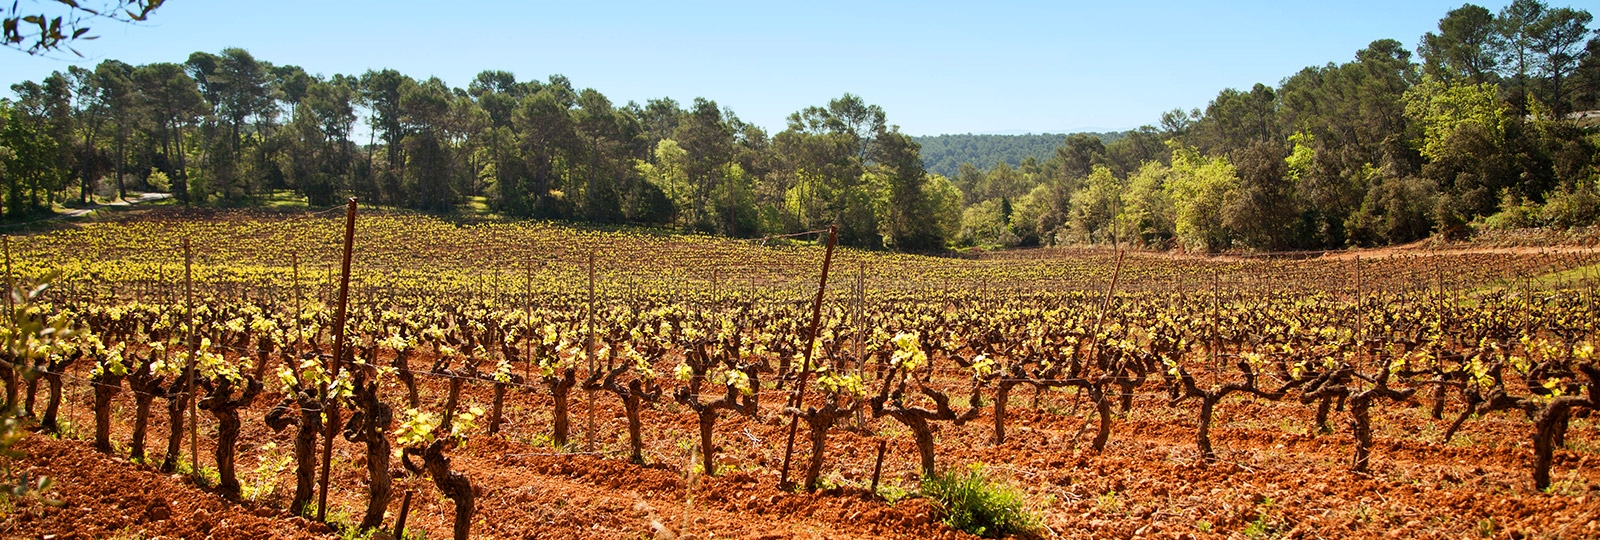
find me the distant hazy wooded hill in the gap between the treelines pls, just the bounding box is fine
[912,133,1123,176]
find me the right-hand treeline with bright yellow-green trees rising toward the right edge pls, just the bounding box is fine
[955,0,1600,251]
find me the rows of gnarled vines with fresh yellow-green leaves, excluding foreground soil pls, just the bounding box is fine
[0,209,1600,538]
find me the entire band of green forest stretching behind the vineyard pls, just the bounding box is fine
[0,0,1600,252]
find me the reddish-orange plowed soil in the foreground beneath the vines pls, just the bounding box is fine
[0,362,1600,538]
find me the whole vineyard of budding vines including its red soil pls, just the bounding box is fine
[0,204,1600,538]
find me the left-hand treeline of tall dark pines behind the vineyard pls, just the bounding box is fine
[0,55,960,251]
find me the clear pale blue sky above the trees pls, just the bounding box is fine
[0,0,1548,134]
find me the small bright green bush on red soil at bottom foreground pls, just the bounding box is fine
[922,465,1043,538]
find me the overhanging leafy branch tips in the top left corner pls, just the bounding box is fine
[0,0,163,56]
